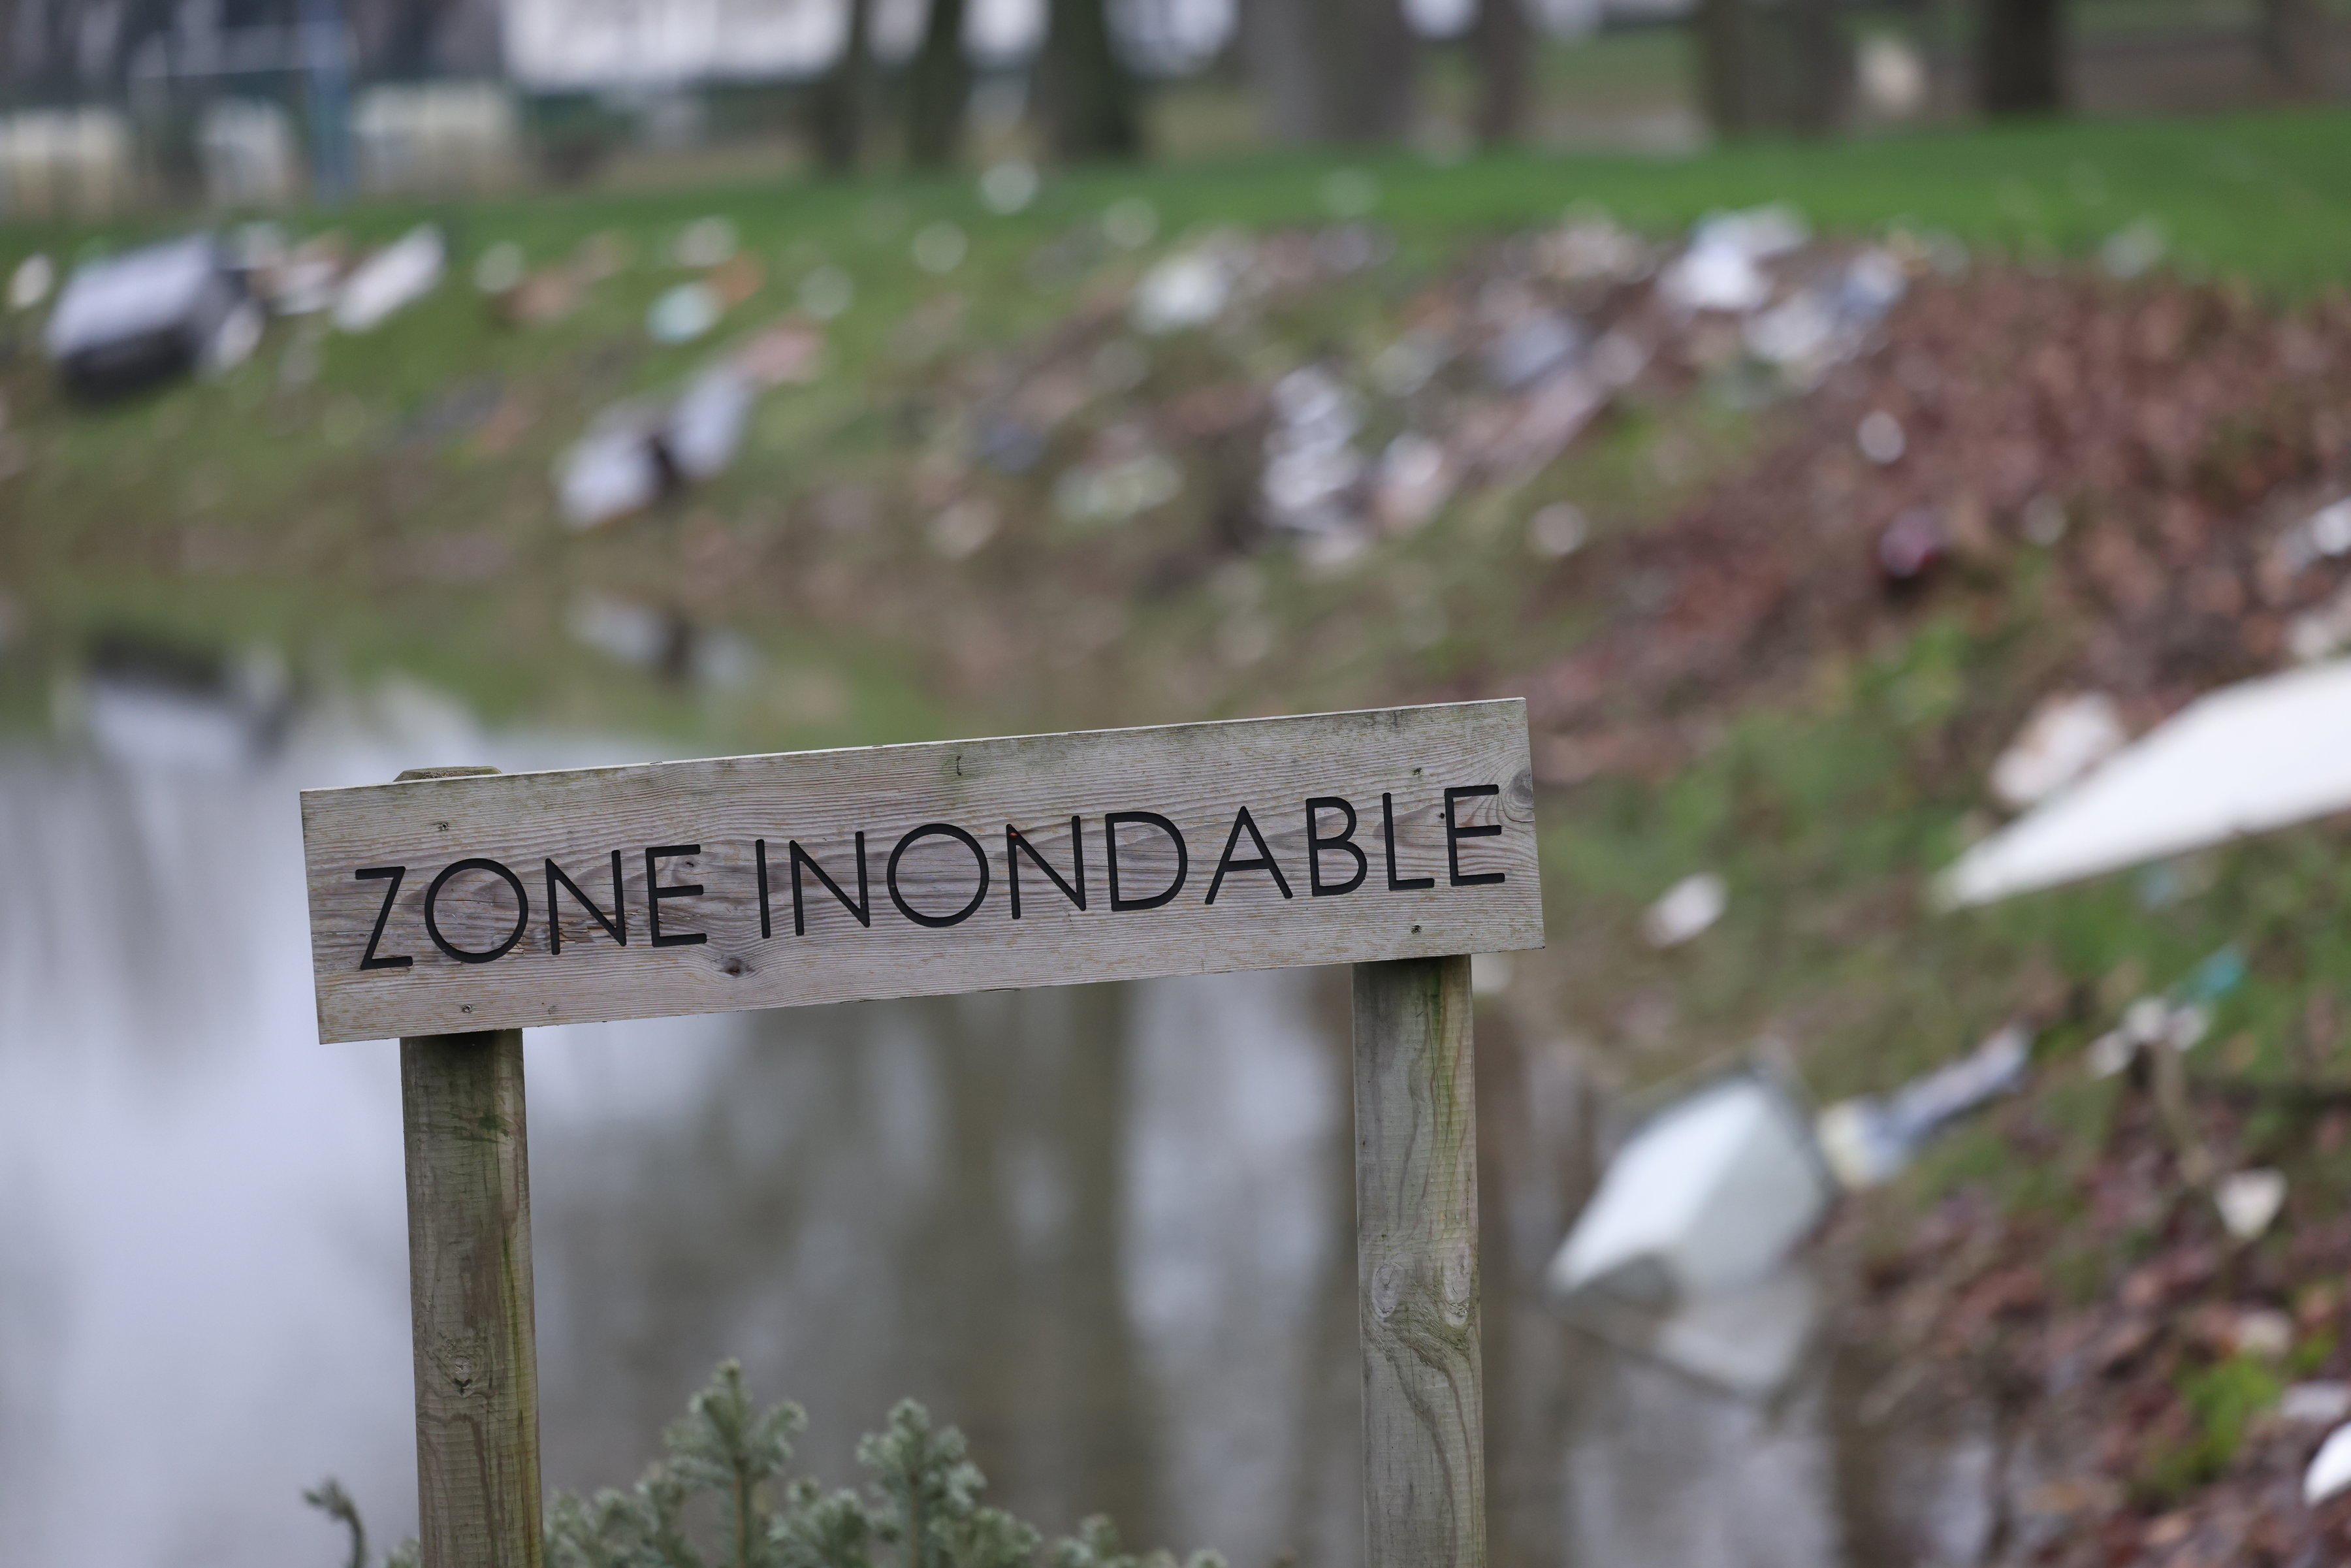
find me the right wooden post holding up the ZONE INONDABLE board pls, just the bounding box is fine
[1354,957,1486,1568]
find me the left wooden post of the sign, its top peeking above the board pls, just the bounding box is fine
[400,769,545,1568]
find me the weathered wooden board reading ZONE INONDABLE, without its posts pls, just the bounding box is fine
[303,701,1543,1042]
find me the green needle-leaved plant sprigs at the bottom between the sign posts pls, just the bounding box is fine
[303,1361,1225,1568]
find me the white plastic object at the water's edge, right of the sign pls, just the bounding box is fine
[1544,1074,1831,1305]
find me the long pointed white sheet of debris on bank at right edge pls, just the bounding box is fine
[1940,661,2351,905]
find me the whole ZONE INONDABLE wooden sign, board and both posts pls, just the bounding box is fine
[303,701,1543,1568]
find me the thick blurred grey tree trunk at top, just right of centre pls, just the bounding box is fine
[1241,0,1418,144]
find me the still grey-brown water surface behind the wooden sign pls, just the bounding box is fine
[0,703,1989,1568]
